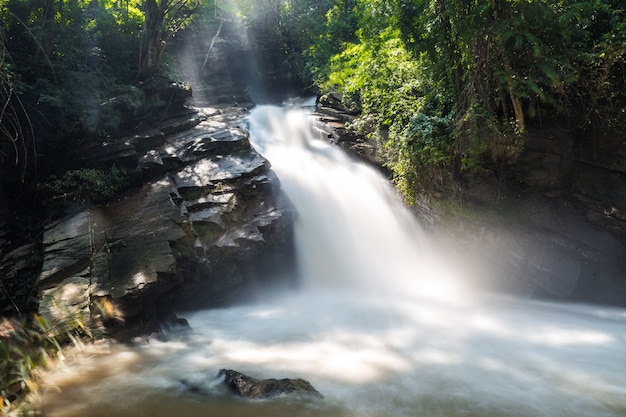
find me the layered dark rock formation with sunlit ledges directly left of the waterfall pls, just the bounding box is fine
[39,108,292,338]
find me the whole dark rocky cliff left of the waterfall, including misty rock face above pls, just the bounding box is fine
[0,14,294,338]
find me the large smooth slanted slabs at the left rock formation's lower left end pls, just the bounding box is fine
[40,180,186,333]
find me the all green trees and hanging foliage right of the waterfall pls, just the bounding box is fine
[312,0,626,200]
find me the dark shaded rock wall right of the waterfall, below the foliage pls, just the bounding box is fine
[454,125,626,306]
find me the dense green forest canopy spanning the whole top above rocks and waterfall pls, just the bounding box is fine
[0,0,626,206]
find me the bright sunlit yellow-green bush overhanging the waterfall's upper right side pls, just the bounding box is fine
[326,23,453,202]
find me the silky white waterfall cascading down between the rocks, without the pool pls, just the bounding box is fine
[249,106,460,300]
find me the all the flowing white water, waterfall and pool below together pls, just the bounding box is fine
[34,102,626,417]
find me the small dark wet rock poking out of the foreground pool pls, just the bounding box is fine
[218,369,322,399]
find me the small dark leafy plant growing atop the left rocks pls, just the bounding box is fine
[42,167,128,203]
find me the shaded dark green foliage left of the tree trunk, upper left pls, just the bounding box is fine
[0,0,142,152]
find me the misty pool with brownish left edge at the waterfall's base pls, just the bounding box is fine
[31,291,626,417]
